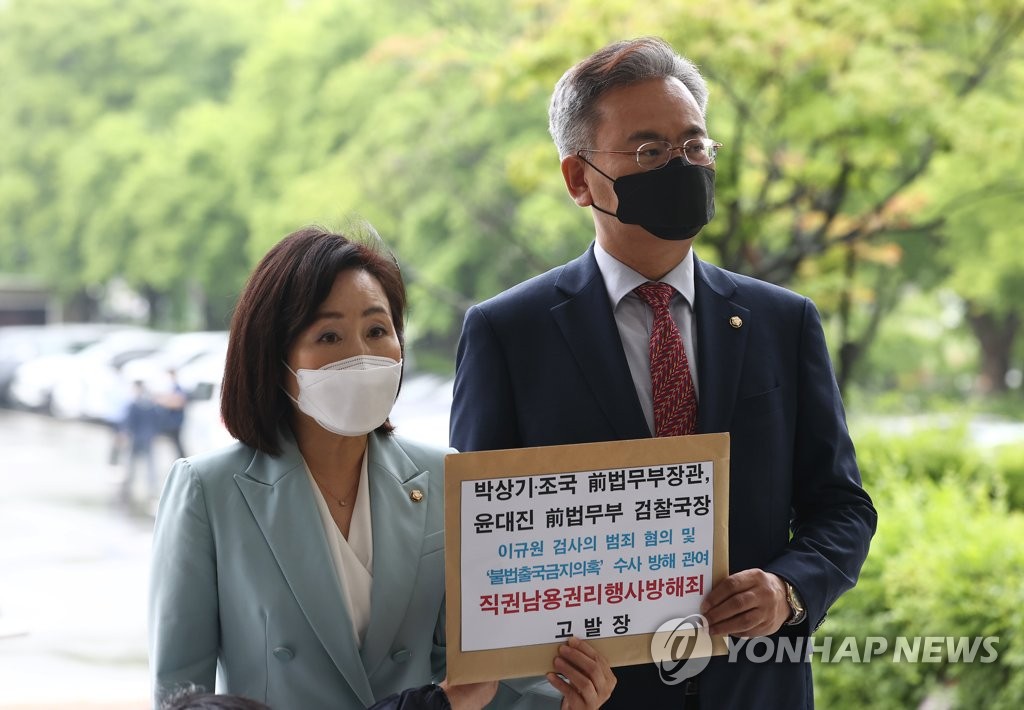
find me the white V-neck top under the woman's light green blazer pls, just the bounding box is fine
[303,452,374,649]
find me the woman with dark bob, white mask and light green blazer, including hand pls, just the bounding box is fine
[150,227,614,710]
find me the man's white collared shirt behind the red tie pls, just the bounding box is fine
[594,242,700,432]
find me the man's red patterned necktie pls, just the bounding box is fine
[633,283,697,436]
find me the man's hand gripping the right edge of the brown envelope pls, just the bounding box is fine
[700,570,791,638]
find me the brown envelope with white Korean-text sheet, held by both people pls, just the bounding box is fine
[444,433,729,683]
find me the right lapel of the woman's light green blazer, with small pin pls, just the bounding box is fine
[361,432,428,675]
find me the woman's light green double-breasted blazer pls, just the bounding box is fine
[151,424,444,709]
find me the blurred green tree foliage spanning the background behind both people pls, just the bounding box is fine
[0,0,1024,388]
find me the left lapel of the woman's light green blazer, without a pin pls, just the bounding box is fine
[234,438,376,706]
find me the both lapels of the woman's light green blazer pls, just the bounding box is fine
[234,432,430,706]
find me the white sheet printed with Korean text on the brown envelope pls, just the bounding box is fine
[462,461,715,651]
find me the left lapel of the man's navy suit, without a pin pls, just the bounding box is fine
[551,245,650,438]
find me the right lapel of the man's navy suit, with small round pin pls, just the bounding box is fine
[693,255,751,433]
